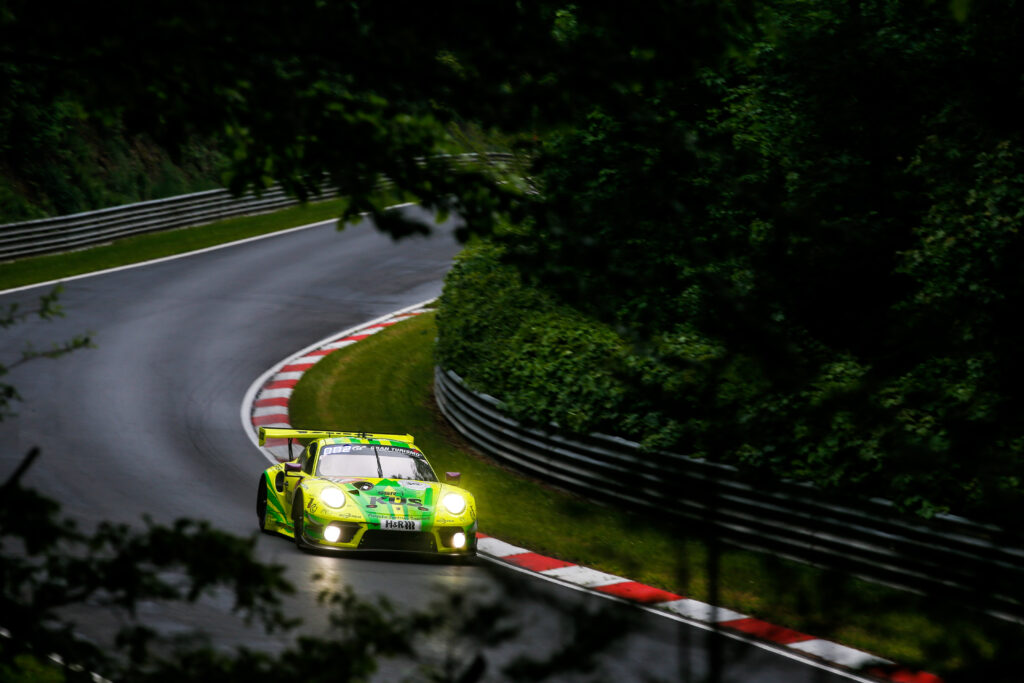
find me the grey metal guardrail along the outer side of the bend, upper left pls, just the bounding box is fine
[0,154,513,261]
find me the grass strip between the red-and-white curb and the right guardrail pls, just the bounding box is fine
[289,314,1022,680]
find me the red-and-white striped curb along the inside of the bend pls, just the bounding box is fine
[242,301,942,683]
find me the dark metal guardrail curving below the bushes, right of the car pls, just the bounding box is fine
[434,368,1024,623]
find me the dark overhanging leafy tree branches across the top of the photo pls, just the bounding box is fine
[0,0,745,236]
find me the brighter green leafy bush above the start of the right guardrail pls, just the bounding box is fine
[436,244,642,433]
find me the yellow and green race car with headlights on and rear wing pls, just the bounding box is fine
[256,427,476,555]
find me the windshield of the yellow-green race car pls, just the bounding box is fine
[316,443,437,481]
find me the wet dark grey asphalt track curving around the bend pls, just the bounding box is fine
[0,208,849,683]
